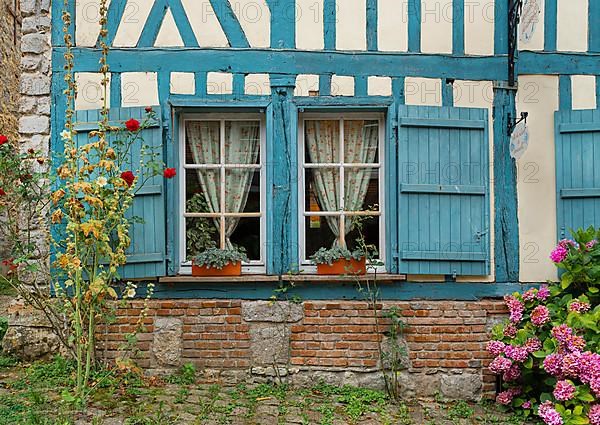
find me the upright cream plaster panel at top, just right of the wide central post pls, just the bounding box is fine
[296,0,325,50]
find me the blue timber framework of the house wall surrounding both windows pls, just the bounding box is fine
[51,0,600,299]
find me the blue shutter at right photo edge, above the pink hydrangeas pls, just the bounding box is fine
[555,109,600,239]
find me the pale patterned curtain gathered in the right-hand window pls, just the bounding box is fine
[305,121,378,245]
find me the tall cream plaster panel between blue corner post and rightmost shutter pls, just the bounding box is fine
[517,75,558,282]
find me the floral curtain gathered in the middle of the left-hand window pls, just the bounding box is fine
[187,121,260,248]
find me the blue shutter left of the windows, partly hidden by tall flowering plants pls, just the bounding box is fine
[75,108,166,279]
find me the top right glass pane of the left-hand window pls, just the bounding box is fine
[225,121,260,164]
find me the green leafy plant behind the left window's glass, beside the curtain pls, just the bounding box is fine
[186,192,217,258]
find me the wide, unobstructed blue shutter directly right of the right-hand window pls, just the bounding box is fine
[397,105,490,276]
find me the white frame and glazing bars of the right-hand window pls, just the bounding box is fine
[298,112,386,274]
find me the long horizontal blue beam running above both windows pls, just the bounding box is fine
[57,48,516,81]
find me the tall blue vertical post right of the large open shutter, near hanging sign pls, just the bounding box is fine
[493,88,519,282]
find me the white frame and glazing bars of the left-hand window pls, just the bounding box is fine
[178,112,267,275]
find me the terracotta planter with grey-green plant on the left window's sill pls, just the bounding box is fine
[192,247,248,276]
